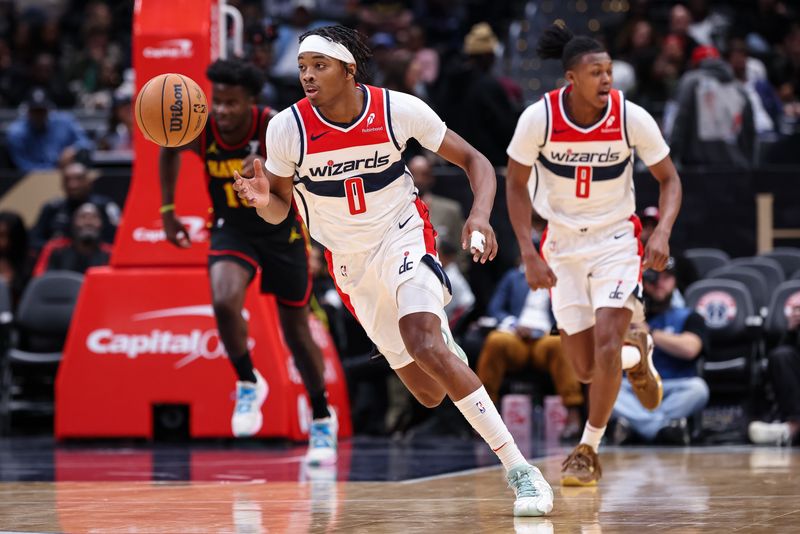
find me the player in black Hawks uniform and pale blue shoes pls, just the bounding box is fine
[159,60,338,465]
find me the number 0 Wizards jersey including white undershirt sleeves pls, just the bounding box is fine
[267,85,447,253]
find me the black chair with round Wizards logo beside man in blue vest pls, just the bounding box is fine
[686,279,761,398]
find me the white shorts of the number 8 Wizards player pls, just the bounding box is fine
[541,215,644,335]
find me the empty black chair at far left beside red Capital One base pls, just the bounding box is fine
[0,271,83,431]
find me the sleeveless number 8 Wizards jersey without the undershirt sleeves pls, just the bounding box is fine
[530,86,636,231]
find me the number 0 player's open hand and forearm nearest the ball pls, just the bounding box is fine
[233,159,294,224]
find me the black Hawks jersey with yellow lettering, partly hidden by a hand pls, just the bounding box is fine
[201,106,295,234]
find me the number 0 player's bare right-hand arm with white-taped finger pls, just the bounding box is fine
[437,129,497,263]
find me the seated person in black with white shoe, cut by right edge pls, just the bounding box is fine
[747,304,800,445]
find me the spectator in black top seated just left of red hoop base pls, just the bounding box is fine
[33,202,111,276]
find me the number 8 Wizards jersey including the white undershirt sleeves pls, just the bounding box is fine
[507,85,669,231]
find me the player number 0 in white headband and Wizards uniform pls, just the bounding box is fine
[234,26,553,516]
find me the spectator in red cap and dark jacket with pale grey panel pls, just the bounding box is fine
[669,46,755,168]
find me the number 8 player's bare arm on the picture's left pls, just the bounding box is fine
[506,157,556,289]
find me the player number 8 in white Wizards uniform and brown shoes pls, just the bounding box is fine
[507,25,681,486]
